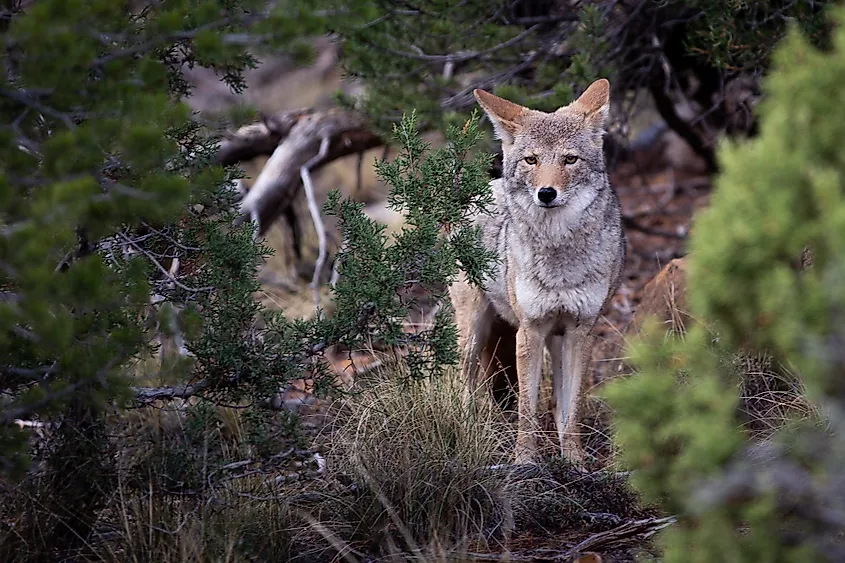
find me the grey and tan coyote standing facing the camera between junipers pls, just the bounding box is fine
[449,79,625,465]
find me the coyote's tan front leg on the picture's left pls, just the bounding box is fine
[516,323,544,464]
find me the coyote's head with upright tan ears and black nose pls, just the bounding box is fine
[474,78,610,216]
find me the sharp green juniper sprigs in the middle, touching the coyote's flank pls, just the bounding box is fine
[326,113,495,375]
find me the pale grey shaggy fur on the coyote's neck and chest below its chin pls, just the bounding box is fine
[479,180,619,333]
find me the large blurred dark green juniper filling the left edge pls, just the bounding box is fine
[0,0,318,480]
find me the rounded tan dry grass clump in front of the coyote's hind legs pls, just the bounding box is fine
[314,371,516,555]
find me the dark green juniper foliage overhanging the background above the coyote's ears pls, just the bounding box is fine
[318,0,831,159]
